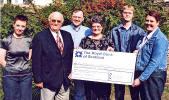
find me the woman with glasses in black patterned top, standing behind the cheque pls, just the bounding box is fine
[79,15,114,100]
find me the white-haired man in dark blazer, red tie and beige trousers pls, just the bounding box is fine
[32,12,74,100]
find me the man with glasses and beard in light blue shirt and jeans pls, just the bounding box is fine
[61,9,92,100]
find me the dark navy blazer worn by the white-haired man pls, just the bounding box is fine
[32,28,74,92]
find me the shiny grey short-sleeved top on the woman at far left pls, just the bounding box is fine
[0,34,32,73]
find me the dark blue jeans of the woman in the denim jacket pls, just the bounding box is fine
[141,71,167,100]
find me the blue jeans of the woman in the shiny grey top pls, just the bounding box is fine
[2,71,32,100]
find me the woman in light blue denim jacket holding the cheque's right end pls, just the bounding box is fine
[132,10,168,100]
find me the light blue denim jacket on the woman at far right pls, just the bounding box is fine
[136,28,168,81]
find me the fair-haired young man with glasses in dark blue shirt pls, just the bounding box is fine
[110,5,144,100]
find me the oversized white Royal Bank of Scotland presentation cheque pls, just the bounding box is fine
[72,49,136,85]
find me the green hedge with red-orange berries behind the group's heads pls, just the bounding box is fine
[0,0,169,38]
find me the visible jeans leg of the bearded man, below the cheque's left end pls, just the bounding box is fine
[74,80,85,100]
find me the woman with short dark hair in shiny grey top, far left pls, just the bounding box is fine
[0,15,32,100]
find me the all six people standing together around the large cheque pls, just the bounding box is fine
[0,5,168,100]
